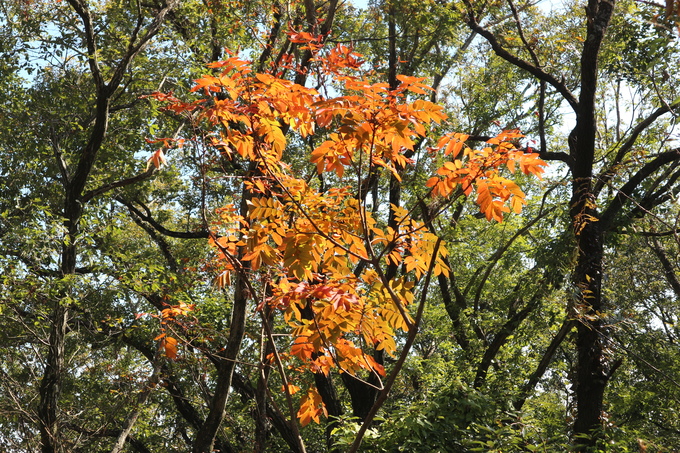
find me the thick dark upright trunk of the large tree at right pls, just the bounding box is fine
[569,0,616,451]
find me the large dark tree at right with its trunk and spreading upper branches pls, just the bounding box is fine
[466,1,680,449]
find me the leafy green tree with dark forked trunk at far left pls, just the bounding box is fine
[2,2,242,451]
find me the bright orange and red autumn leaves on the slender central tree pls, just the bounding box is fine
[151,34,545,425]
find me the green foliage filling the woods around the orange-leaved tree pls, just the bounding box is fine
[0,0,680,452]
